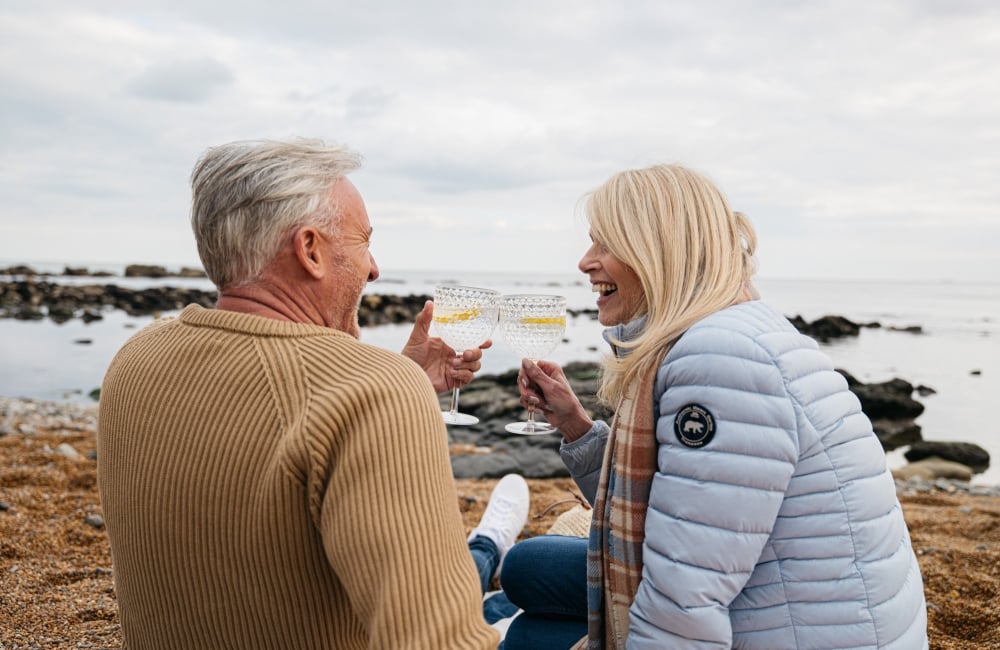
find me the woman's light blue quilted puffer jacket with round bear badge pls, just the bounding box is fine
[562,301,927,650]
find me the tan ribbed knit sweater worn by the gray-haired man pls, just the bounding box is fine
[97,305,498,650]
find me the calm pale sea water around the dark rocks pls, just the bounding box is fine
[0,265,1000,485]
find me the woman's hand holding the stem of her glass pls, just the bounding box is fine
[517,359,594,442]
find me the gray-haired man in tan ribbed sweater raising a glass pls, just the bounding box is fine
[98,140,527,649]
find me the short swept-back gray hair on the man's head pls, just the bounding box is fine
[191,139,361,291]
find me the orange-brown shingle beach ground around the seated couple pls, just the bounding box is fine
[0,400,1000,650]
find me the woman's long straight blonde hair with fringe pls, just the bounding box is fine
[585,165,757,406]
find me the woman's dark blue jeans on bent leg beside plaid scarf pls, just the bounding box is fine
[500,535,587,650]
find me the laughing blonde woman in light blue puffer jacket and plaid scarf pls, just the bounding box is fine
[501,165,927,650]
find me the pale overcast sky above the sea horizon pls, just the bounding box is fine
[0,0,1000,282]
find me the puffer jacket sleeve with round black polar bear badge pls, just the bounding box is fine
[628,327,798,650]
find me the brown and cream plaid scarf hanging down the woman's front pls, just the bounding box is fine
[574,367,657,650]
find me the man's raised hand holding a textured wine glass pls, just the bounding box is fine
[403,300,493,393]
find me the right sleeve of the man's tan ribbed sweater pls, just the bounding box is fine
[316,361,498,650]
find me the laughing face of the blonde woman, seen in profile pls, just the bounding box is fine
[579,233,646,327]
